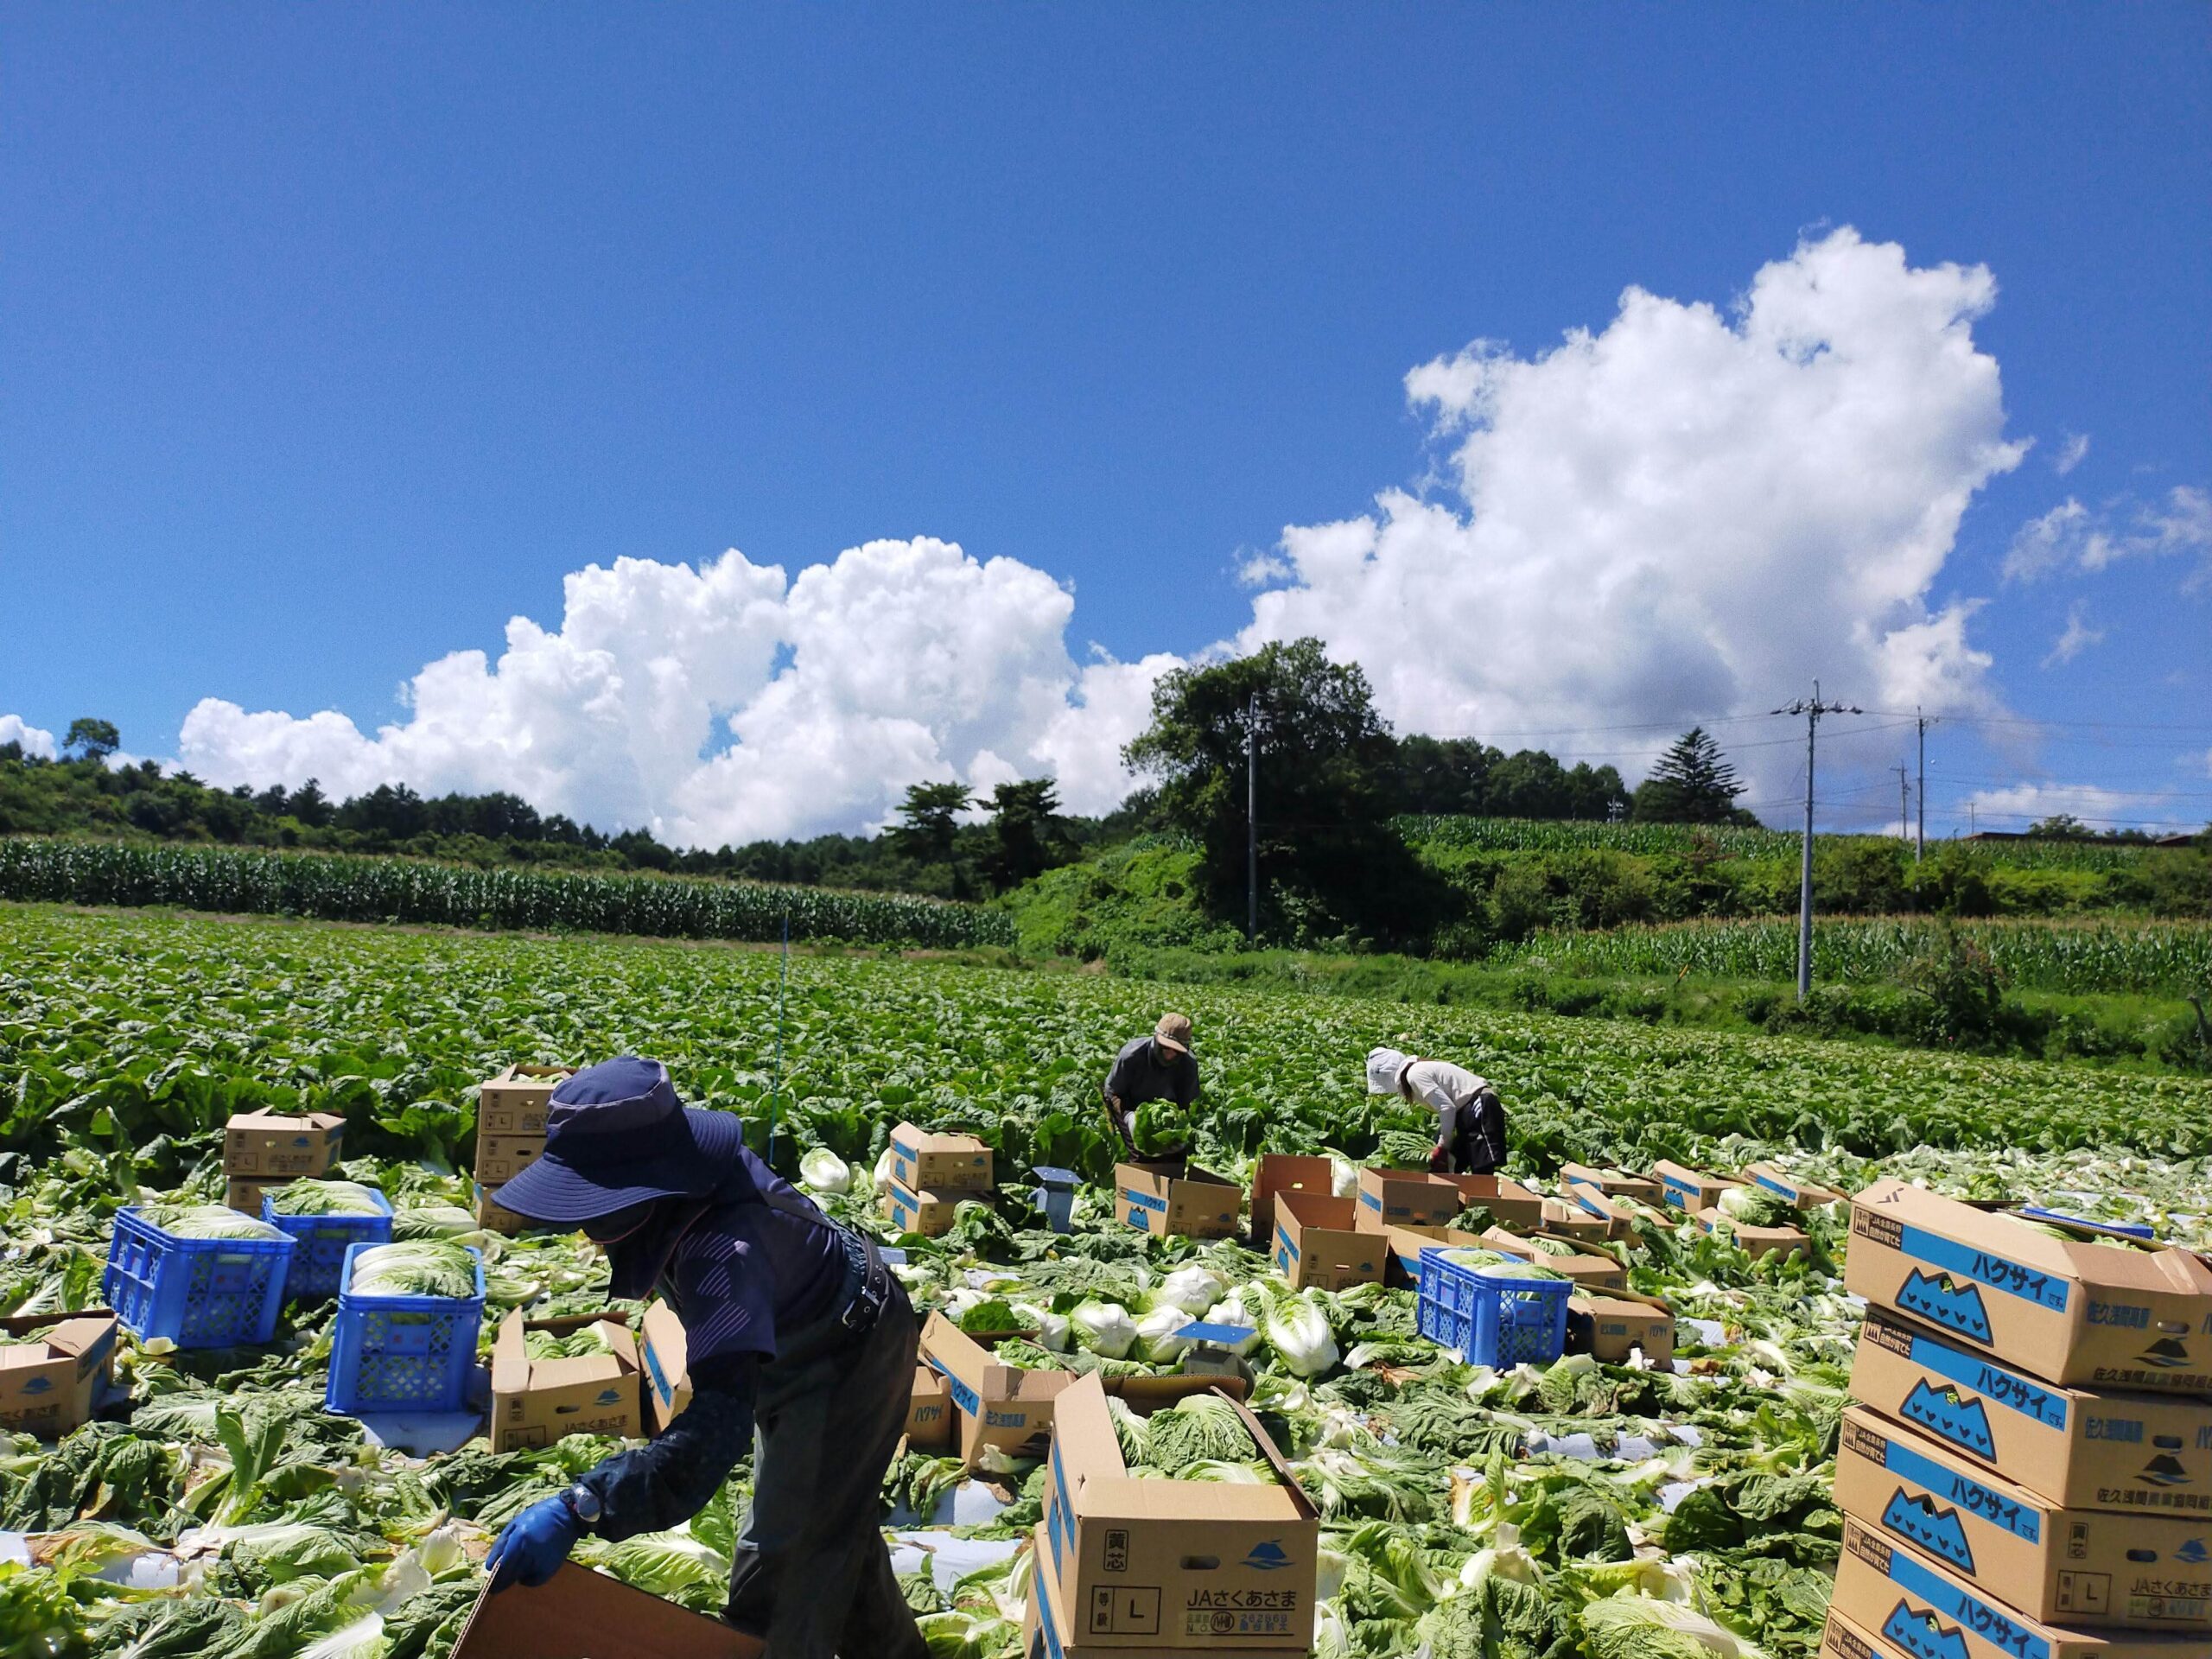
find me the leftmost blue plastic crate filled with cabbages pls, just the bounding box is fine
[99,1205,294,1347]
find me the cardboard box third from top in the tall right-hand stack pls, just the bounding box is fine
[1836,1405,2212,1630]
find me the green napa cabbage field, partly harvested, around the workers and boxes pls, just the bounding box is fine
[0,907,2212,1659]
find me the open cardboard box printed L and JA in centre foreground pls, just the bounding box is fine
[1038,1376,1320,1652]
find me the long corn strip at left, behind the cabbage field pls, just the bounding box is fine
[0,836,1013,949]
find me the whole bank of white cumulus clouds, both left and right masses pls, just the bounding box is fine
[156,230,2026,845]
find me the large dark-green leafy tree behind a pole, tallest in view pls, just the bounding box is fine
[1122,639,1435,943]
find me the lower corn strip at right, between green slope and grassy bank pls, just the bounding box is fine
[1489,916,2212,995]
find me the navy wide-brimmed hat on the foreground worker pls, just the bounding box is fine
[500,1055,746,1221]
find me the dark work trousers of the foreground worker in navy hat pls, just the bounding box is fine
[726,1279,929,1659]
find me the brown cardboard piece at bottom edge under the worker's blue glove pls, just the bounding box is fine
[454,1561,761,1659]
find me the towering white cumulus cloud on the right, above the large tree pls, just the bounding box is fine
[1241,230,2026,791]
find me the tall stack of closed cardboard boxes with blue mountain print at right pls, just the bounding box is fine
[1821,1181,2212,1659]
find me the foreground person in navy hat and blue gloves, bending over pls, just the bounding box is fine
[485,1058,929,1659]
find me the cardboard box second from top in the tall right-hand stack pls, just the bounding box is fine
[1852,1307,2212,1520]
